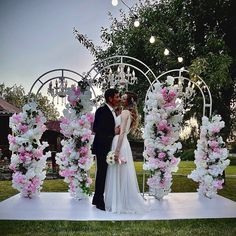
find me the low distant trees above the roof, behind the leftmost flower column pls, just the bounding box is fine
[0,83,59,120]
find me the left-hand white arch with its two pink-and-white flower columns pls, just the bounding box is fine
[8,69,96,199]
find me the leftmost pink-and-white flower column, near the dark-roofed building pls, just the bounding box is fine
[8,102,51,198]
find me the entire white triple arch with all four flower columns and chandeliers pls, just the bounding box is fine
[9,58,229,199]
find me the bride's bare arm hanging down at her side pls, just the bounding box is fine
[115,110,130,161]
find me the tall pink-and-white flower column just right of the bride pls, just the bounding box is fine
[143,76,183,199]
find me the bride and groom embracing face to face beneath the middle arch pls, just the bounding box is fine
[92,88,147,213]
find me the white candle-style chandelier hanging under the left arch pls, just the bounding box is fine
[47,76,69,104]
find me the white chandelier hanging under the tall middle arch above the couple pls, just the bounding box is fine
[107,64,137,89]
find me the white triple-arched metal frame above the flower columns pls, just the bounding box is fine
[26,55,212,194]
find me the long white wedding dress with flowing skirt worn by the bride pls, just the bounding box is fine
[105,110,148,213]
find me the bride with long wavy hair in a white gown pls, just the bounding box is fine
[105,92,147,213]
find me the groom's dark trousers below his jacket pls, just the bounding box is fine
[93,154,108,205]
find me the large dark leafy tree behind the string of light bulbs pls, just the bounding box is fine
[74,0,236,138]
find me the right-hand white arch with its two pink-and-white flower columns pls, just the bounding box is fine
[143,68,229,199]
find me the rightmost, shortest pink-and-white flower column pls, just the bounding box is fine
[188,115,230,198]
